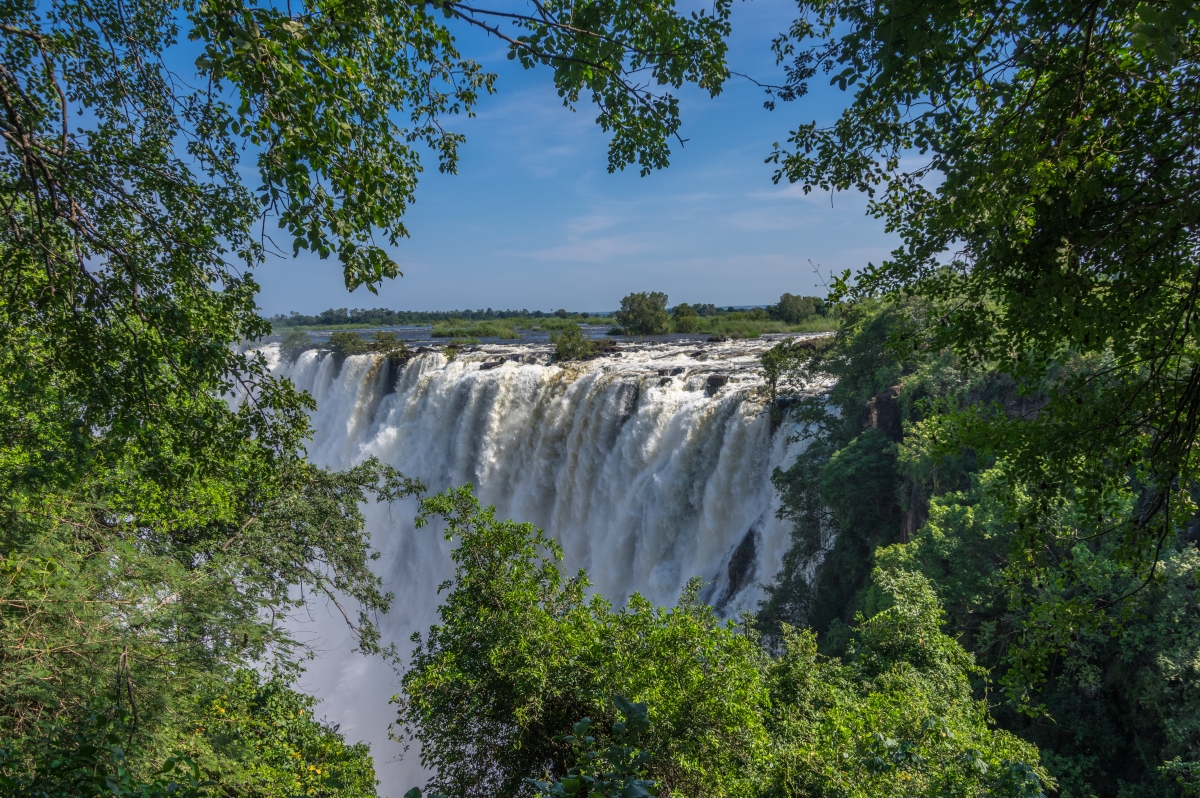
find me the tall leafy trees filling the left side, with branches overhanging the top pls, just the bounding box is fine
[0,0,728,796]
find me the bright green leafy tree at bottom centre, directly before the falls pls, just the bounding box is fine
[398,487,768,798]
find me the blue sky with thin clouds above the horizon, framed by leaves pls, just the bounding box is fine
[256,0,895,314]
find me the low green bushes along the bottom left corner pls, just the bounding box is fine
[0,670,376,798]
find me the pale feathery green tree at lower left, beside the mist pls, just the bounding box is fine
[0,460,420,779]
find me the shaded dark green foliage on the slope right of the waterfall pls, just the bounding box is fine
[760,302,1200,798]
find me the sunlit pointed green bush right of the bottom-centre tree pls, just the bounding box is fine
[763,570,1055,798]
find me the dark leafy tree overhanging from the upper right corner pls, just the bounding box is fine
[774,0,1200,634]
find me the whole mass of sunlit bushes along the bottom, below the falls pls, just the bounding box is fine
[397,488,1054,798]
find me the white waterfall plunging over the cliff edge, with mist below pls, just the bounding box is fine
[266,341,825,798]
